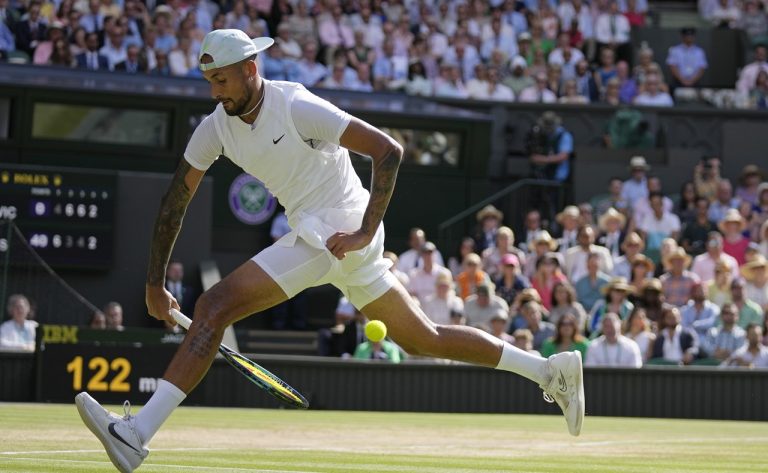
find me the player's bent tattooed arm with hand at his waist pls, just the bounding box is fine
[326,118,403,259]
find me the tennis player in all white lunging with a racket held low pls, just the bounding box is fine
[76,30,584,472]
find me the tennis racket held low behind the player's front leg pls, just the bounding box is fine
[171,309,309,409]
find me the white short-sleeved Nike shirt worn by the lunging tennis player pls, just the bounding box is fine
[184,80,369,229]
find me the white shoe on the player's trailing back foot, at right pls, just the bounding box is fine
[540,351,584,436]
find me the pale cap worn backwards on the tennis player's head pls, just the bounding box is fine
[198,29,275,71]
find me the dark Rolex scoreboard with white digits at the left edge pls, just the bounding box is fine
[0,164,117,269]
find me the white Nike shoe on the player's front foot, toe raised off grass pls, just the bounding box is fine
[75,392,149,473]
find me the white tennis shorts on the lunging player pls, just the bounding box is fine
[251,209,397,309]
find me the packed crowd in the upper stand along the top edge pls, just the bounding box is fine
[0,0,768,108]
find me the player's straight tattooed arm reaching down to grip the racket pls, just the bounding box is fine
[146,159,205,322]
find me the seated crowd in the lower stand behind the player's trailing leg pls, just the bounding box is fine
[328,156,768,368]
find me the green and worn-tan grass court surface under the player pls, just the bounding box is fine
[0,404,768,473]
